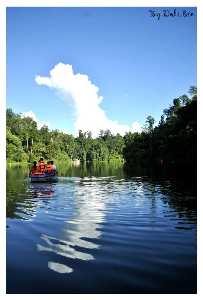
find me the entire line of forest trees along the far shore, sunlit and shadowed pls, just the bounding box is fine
[6,86,197,175]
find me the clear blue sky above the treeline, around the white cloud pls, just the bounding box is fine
[7,7,196,133]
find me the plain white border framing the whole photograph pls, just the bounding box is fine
[0,0,203,300]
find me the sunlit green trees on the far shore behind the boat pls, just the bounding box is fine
[7,109,124,162]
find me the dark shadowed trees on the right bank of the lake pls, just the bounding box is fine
[123,87,197,176]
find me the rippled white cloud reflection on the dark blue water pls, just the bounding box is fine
[37,179,106,273]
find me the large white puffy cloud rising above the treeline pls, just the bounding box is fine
[35,63,141,137]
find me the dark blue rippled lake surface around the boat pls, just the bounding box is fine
[7,167,196,293]
